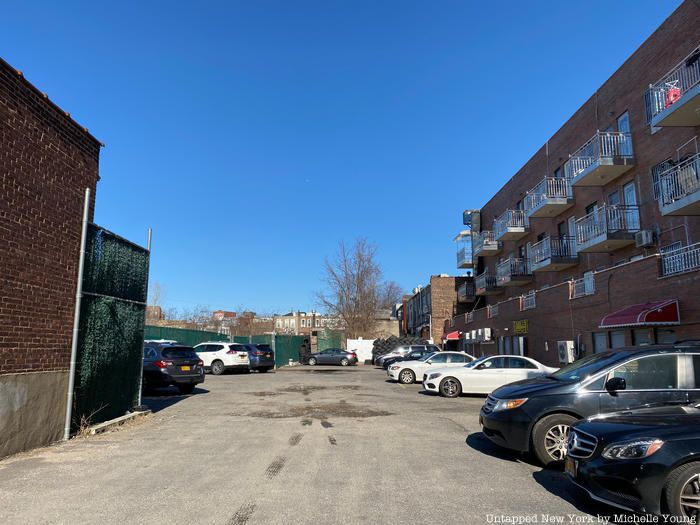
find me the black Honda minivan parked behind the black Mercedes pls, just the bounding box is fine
[480,342,700,465]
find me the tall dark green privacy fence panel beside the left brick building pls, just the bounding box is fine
[71,224,150,430]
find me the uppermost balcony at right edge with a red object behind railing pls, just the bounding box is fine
[646,47,700,127]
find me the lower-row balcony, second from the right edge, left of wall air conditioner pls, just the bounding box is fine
[576,204,640,253]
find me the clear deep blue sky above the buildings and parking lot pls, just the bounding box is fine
[0,0,680,312]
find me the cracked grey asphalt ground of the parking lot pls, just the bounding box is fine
[0,366,611,524]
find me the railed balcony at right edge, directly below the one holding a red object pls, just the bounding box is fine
[659,153,700,215]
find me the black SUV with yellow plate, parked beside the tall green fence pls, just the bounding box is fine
[142,343,204,394]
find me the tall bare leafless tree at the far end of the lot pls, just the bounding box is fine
[316,239,383,338]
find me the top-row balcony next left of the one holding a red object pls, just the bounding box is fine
[564,131,634,186]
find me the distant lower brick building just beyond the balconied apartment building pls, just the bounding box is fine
[402,274,474,342]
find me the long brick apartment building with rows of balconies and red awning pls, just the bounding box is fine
[452,0,700,365]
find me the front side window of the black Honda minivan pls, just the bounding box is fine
[610,355,678,390]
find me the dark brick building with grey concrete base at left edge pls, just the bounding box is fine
[0,59,100,457]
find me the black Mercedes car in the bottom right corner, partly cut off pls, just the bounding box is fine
[566,404,700,523]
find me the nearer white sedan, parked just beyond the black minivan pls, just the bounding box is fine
[423,355,558,397]
